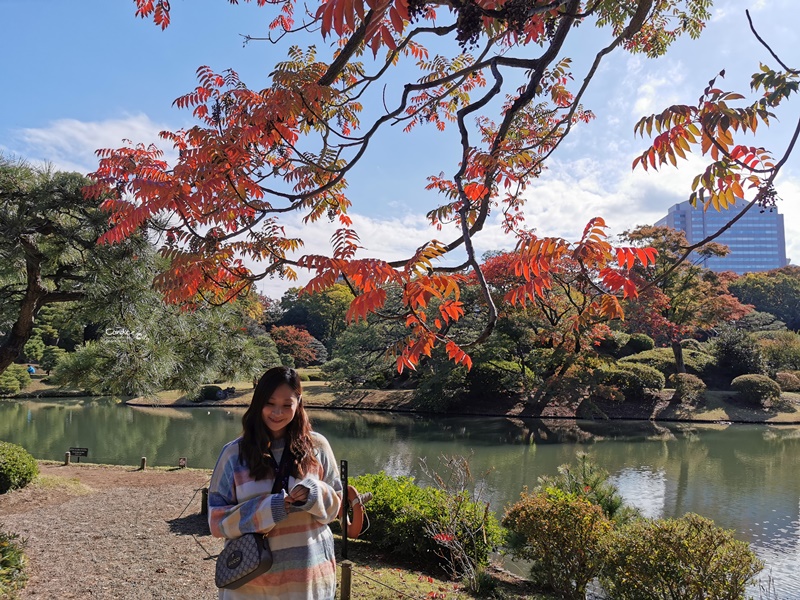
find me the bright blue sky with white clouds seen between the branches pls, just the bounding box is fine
[0,0,800,296]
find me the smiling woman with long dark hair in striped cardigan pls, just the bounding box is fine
[208,367,342,600]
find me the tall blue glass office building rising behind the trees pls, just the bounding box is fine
[656,200,789,275]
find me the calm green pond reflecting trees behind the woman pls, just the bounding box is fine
[0,399,800,598]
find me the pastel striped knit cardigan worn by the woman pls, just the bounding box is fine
[208,433,342,600]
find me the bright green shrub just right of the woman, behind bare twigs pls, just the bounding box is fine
[350,471,502,567]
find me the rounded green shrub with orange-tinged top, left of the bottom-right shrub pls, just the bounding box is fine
[503,488,612,599]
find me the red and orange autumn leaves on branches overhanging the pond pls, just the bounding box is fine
[88,0,792,370]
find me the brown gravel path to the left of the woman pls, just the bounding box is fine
[0,465,222,600]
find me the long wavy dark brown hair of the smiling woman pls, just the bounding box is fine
[239,367,319,480]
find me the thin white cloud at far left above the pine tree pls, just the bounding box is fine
[6,113,171,173]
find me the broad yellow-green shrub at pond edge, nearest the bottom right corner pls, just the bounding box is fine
[600,514,764,600]
